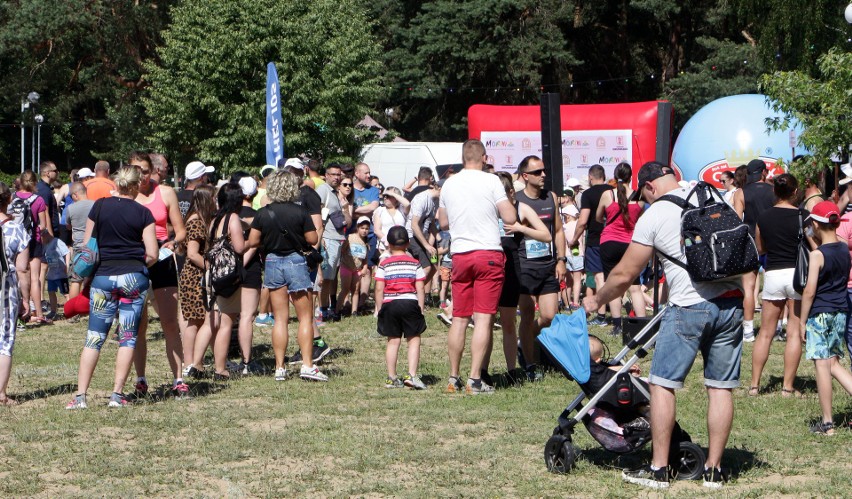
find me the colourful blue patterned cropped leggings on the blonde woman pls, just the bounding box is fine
[86,272,149,350]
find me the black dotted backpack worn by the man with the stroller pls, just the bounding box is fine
[657,182,760,282]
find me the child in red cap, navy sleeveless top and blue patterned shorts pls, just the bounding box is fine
[801,201,852,435]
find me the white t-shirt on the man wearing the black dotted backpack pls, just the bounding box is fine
[633,188,742,307]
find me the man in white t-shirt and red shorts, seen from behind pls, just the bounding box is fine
[438,139,517,395]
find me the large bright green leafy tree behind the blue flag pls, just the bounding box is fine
[143,0,380,171]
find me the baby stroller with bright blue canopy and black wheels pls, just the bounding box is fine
[538,307,705,480]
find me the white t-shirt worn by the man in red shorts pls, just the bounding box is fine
[439,168,506,254]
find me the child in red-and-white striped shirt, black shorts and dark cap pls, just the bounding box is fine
[376,226,426,390]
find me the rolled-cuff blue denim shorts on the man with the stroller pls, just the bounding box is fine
[648,298,743,389]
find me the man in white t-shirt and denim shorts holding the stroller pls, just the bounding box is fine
[583,162,744,489]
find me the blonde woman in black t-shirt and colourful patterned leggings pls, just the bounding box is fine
[66,167,157,409]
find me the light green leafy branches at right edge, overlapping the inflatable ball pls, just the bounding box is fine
[761,49,852,174]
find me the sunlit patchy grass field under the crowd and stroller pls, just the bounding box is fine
[0,314,852,497]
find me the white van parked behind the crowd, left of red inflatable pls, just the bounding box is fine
[361,142,462,189]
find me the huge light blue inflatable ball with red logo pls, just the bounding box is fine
[672,94,807,188]
